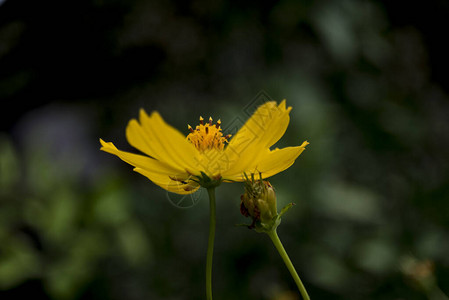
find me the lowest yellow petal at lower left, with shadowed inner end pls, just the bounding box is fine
[134,168,200,195]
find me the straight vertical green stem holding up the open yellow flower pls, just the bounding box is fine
[206,187,215,300]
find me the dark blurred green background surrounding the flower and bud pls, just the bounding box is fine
[0,0,449,300]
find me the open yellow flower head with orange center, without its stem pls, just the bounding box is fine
[100,100,309,194]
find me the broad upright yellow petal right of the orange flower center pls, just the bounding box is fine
[223,100,291,174]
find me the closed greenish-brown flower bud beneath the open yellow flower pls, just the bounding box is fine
[240,176,277,227]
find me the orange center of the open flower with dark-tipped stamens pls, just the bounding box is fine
[187,117,231,152]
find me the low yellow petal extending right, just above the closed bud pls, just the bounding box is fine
[223,141,309,181]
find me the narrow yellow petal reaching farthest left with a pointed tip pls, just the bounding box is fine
[100,139,189,179]
